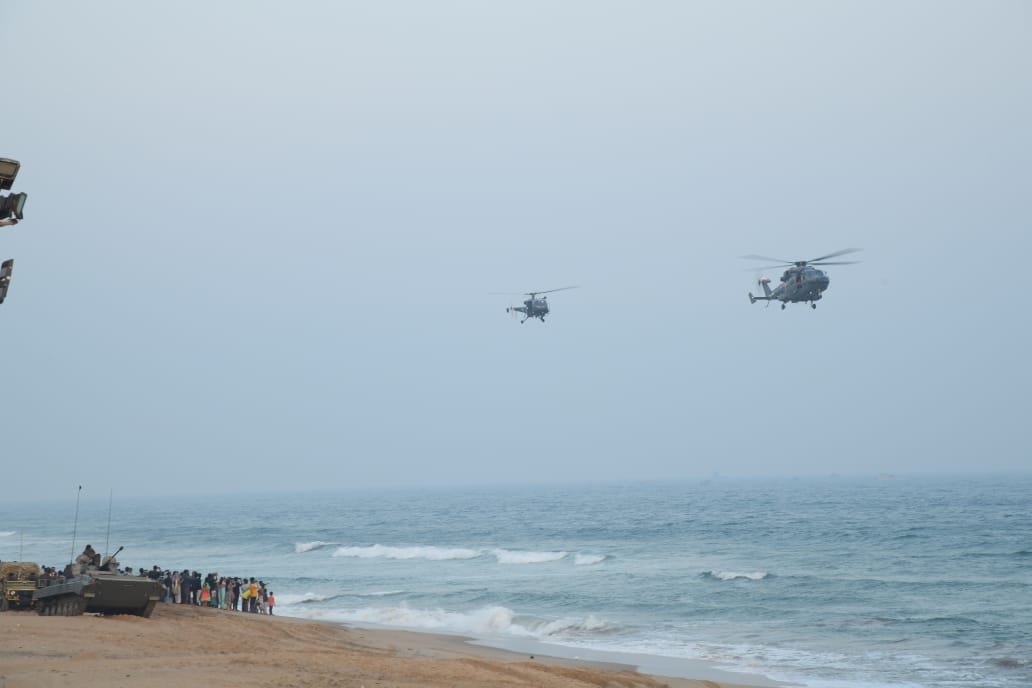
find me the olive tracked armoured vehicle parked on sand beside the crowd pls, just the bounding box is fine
[33,564,164,617]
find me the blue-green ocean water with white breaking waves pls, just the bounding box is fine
[0,474,1032,688]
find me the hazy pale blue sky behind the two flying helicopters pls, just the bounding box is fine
[0,0,1032,499]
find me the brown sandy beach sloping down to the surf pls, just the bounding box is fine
[0,604,759,688]
